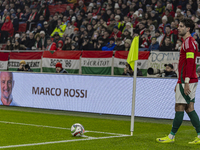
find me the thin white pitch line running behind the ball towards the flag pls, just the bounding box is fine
[0,121,126,136]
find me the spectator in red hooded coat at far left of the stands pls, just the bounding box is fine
[1,16,14,43]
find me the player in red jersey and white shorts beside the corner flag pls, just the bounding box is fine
[156,18,200,144]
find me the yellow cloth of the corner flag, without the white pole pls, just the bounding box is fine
[127,36,139,71]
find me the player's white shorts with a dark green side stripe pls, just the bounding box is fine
[175,83,198,104]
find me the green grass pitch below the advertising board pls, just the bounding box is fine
[0,106,200,150]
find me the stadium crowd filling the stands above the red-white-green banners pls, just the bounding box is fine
[0,0,200,51]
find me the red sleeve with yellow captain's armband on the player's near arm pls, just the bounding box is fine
[184,38,197,78]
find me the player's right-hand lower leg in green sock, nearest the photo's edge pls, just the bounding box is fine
[185,102,200,144]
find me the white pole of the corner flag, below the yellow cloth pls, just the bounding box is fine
[131,60,137,136]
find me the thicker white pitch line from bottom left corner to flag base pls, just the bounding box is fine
[0,135,130,149]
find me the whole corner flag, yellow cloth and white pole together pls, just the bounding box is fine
[127,36,139,136]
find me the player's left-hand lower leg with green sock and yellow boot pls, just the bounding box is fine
[156,104,186,143]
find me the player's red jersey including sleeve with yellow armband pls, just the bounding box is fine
[178,36,198,83]
